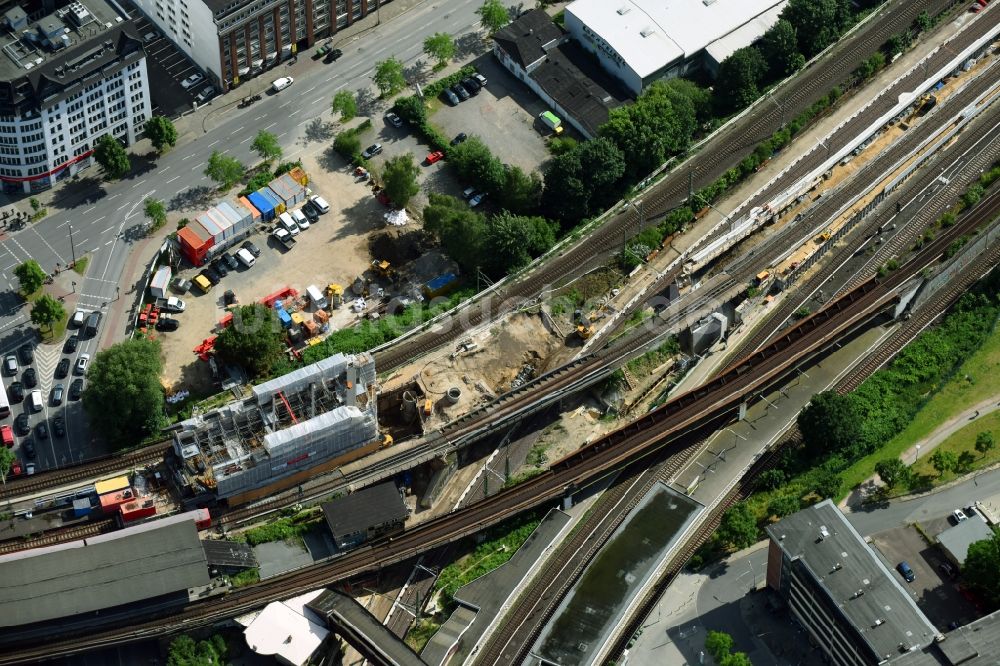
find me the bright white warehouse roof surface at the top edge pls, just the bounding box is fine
[566,0,784,77]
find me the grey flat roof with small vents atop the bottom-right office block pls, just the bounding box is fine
[767,500,939,656]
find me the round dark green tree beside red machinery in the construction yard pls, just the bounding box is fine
[215,303,285,378]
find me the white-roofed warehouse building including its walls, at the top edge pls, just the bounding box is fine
[565,0,787,95]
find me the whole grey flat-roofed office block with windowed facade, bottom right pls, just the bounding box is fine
[767,500,941,666]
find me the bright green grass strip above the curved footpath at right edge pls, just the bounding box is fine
[842,316,1000,495]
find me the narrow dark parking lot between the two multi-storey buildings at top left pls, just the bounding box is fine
[123,2,208,118]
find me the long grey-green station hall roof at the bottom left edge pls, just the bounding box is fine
[0,520,209,627]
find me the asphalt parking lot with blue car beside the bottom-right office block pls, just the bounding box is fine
[872,518,978,631]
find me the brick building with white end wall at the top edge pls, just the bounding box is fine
[135,0,388,91]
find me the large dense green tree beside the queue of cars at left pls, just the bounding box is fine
[83,338,166,449]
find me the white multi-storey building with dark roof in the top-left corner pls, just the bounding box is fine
[0,0,152,192]
